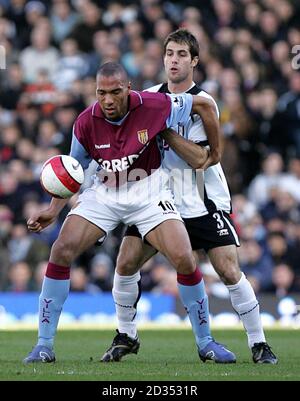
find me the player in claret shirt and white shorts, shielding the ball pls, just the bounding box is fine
[24,63,236,363]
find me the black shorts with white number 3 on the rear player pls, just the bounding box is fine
[124,211,240,251]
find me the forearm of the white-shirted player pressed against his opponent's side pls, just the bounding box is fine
[161,129,208,169]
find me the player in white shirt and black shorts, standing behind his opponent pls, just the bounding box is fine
[102,29,277,364]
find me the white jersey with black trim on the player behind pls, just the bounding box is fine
[147,84,231,218]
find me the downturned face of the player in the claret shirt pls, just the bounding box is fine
[96,74,130,121]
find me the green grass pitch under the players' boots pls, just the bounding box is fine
[0,330,300,381]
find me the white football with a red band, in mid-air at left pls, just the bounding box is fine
[40,155,84,199]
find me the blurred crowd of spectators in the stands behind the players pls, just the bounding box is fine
[0,0,300,297]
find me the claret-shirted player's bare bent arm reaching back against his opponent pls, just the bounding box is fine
[193,96,221,165]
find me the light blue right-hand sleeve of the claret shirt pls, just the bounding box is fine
[166,93,193,128]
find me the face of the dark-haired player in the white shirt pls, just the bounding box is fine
[164,42,198,83]
